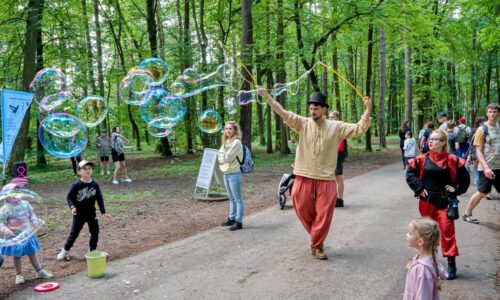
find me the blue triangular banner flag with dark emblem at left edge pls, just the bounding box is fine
[0,90,33,167]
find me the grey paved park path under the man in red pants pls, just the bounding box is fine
[12,164,500,299]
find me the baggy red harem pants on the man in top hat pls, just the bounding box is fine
[292,176,337,248]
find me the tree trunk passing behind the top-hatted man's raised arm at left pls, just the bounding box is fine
[276,0,290,154]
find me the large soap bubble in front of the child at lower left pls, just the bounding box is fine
[0,189,47,248]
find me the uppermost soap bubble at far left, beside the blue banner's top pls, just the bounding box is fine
[30,68,68,100]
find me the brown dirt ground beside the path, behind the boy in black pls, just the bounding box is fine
[0,145,401,298]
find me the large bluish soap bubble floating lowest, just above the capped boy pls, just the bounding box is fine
[38,114,88,158]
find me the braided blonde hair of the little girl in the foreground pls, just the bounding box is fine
[410,218,443,291]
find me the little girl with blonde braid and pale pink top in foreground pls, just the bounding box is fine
[403,218,448,300]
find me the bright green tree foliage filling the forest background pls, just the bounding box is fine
[0,0,500,162]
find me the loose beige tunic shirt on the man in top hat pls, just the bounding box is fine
[285,113,371,180]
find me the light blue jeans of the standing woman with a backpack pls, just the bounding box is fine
[224,172,245,223]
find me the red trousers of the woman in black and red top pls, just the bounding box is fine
[418,200,458,257]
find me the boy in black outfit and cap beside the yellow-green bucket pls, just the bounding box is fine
[57,160,107,260]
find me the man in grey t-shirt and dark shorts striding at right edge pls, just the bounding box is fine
[462,104,500,224]
